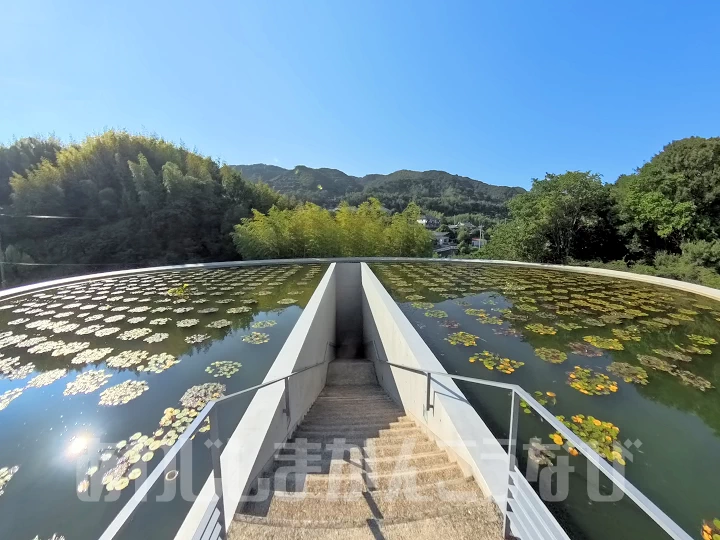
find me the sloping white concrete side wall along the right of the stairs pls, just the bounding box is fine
[362,264,509,508]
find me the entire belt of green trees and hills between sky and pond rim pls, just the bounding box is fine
[5,131,720,287]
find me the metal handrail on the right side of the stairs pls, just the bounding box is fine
[372,340,693,540]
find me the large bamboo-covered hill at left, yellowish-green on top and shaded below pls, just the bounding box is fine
[0,131,291,283]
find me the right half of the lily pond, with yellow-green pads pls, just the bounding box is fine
[372,263,720,539]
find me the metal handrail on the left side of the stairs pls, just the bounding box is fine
[99,341,335,540]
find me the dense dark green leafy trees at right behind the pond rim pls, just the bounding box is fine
[477,137,720,288]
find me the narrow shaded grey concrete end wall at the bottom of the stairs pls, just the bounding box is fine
[335,263,363,358]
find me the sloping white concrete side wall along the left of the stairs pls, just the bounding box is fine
[175,264,337,540]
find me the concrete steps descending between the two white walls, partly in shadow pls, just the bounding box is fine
[228,360,502,540]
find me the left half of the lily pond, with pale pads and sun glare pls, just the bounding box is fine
[0,264,327,540]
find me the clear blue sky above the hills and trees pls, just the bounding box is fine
[0,0,720,187]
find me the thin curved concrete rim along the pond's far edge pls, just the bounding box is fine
[0,257,720,301]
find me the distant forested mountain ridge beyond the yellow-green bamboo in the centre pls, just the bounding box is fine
[234,164,525,216]
